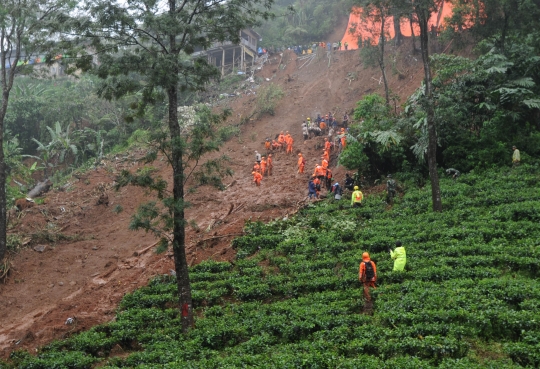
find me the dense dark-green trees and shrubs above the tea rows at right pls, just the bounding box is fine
[341,32,540,184]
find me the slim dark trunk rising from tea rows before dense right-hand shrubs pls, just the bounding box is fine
[416,7,442,211]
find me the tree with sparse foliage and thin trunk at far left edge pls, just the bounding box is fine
[0,0,72,260]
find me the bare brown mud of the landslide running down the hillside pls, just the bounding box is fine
[0,38,430,357]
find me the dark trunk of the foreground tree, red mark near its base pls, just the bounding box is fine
[167,0,193,333]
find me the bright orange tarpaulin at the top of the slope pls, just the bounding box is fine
[341,2,452,50]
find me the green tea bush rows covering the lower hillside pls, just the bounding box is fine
[4,166,540,369]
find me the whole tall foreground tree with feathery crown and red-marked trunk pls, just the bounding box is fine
[70,0,273,332]
